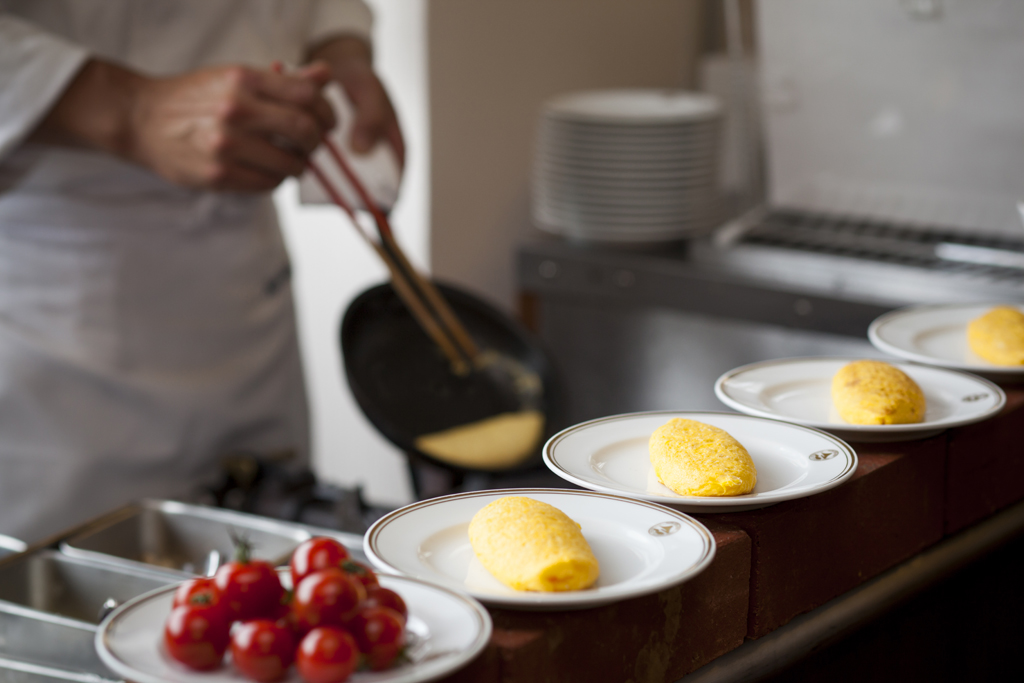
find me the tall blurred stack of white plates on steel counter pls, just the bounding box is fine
[534,90,722,243]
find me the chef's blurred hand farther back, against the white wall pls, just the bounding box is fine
[309,36,406,166]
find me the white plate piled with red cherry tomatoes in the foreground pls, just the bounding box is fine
[95,537,492,683]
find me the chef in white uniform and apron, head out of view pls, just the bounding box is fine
[0,0,402,541]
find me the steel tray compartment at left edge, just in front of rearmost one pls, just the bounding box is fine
[0,550,178,626]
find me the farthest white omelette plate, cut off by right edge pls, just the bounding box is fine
[867,303,1024,380]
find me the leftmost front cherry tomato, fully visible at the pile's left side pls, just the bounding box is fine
[164,604,231,671]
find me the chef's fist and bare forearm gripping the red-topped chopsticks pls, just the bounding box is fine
[34,60,335,191]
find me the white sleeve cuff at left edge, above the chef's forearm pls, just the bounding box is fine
[0,13,89,159]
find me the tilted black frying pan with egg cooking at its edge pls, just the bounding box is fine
[341,284,558,471]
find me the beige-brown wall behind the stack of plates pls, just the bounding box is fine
[427,0,703,310]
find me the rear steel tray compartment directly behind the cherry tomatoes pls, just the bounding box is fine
[60,501,311,577]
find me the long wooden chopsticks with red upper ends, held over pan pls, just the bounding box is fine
[308,138,480,375]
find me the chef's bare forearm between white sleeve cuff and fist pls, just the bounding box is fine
[30,58,148,160]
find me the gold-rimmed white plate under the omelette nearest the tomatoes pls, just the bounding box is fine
[364,488,715,610]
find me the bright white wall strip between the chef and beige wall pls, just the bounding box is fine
[274,0,429,506]
